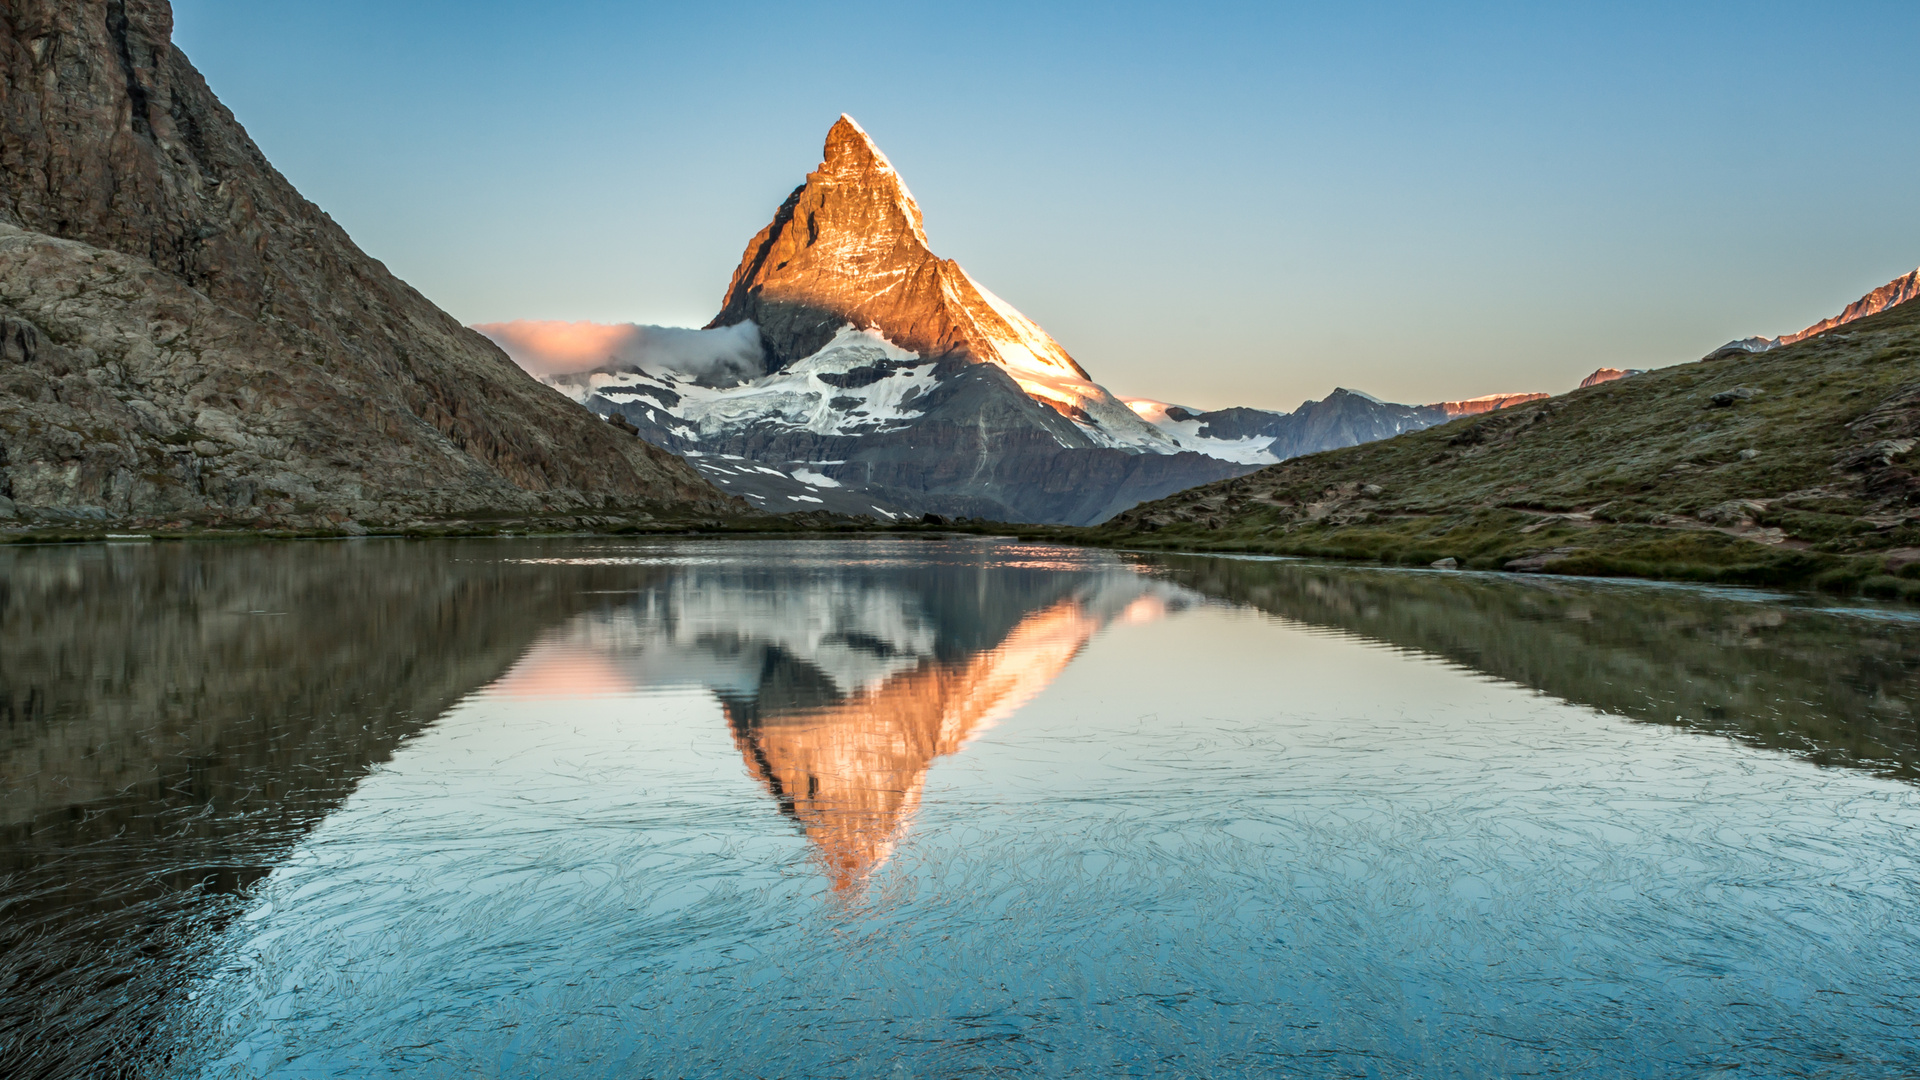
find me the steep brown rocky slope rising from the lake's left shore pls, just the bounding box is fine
[0,0,745,532]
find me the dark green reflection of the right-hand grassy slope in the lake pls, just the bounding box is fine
[1156,555,1920,780]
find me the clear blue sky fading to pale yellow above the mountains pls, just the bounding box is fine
[175,0,1920,407]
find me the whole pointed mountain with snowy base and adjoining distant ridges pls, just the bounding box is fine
[491,115,1544,525]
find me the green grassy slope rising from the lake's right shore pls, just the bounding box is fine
[1085,294,1920,596]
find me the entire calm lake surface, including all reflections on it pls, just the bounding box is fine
[0,538,1920,1078]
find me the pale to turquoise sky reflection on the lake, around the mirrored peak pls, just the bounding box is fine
[176,568,1920,1076]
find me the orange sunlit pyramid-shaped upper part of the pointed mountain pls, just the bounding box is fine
[708,113,1175,452]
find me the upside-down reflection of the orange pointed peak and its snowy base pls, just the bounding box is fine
[492,538,1196,897]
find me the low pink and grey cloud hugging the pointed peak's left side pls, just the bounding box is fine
[474,319,766,386]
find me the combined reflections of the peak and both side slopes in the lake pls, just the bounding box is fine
[0,540,1920,1078]
